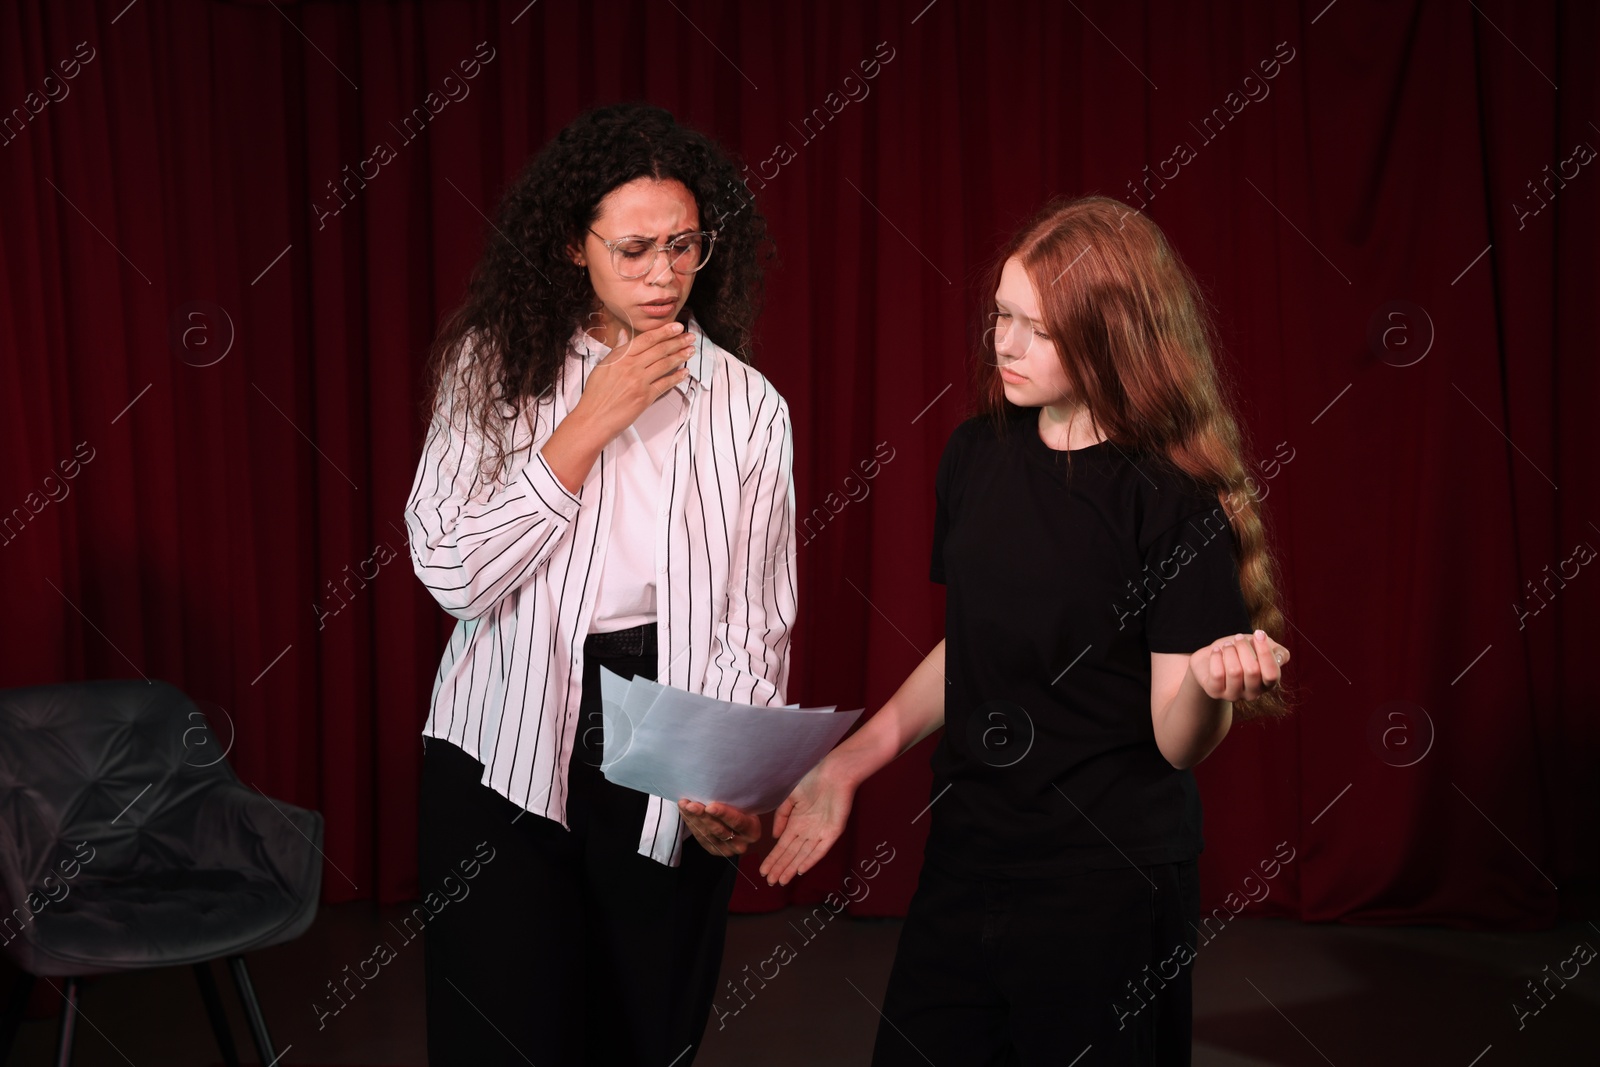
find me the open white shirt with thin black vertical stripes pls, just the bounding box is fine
[405,318,795,867]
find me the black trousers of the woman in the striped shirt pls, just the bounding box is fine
[419,630,738,1067]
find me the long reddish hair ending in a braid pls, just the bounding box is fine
[976,197,1288,721]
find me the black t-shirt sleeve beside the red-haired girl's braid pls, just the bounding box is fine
[1144,506,1251,654]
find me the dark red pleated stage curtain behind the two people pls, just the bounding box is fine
[0,0,1600,928]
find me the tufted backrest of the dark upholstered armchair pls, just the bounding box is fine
[0,678,238,907]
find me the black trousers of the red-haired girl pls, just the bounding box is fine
[872,861,1200,1067]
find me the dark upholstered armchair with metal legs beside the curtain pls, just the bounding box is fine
[0,680,322,1067]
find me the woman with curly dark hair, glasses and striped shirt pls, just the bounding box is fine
[405,106,795,1067]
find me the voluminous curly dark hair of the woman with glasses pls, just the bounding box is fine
[426,104,773,478]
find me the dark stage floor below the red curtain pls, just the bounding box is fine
[10,904,1600,1067]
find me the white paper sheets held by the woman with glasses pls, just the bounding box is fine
[600,667,864,813]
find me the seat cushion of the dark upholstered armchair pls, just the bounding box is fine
[11,870,317,976]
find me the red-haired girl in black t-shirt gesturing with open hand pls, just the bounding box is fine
[762,197,1288,1065]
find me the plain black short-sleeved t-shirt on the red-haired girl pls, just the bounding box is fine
[926,405,1251,877]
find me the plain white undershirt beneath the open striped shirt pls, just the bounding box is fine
[589,342,688,633]
